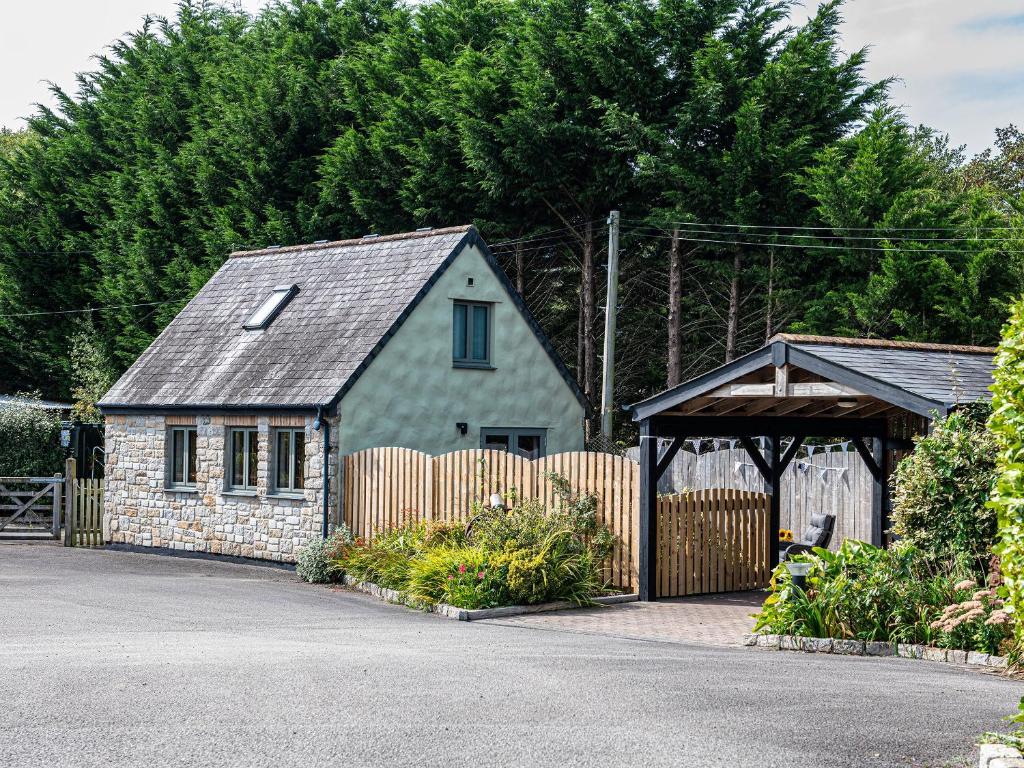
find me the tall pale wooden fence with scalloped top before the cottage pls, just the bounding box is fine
[342,447,640,589]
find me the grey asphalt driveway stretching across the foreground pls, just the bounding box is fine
[0,544,1024,768]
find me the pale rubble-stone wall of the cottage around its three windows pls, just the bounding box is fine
[104,415,339,562]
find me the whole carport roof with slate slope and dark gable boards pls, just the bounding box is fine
[630,334,995,421]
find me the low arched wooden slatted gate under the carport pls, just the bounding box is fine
[657,488,774,597]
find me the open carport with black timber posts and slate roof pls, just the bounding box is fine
[630,334,995,600]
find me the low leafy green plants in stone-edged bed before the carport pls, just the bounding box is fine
[756,540,1008,652]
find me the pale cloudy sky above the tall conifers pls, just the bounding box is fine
[0,0,1024,153]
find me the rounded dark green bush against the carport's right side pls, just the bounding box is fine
[892,402,996,573]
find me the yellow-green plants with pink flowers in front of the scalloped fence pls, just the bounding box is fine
[337,475,614,608]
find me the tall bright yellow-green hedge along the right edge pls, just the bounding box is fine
[988,299,1024,641]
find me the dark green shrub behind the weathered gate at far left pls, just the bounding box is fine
[0,395,63,477]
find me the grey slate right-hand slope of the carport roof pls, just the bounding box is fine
[772,334,995,406]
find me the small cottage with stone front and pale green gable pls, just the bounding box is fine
[99,226,586,561]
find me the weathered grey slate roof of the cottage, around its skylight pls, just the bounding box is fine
[99,226,582,410]
